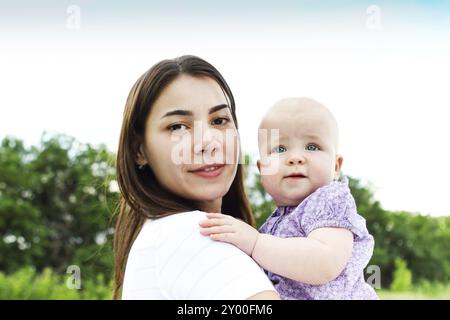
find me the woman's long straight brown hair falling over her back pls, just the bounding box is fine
[113,56,254,299]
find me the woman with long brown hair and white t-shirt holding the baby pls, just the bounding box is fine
[114,56,278,299]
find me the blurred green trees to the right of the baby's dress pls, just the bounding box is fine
[350,174,450,287]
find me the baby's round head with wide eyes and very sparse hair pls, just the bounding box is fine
[258,99,342,206]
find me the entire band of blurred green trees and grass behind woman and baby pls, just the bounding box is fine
[0,134,450,299]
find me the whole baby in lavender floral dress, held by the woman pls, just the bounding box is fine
[200,98,378,299]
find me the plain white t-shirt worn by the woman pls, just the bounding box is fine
[122,211,275,300]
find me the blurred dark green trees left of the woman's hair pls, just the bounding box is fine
[0,134,117,279]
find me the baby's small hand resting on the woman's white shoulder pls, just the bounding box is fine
[199,213,259,256]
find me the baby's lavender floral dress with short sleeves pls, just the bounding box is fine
[260,177,378,300]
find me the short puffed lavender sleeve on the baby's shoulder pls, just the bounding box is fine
[301,178,367,237]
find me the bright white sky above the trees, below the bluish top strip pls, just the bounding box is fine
[0,1,450,215]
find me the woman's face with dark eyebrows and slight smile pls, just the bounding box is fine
[138,75,239,211]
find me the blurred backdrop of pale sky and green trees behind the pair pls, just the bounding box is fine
[0,0,450,299]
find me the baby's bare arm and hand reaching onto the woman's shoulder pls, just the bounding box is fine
[200,213,353,285]
